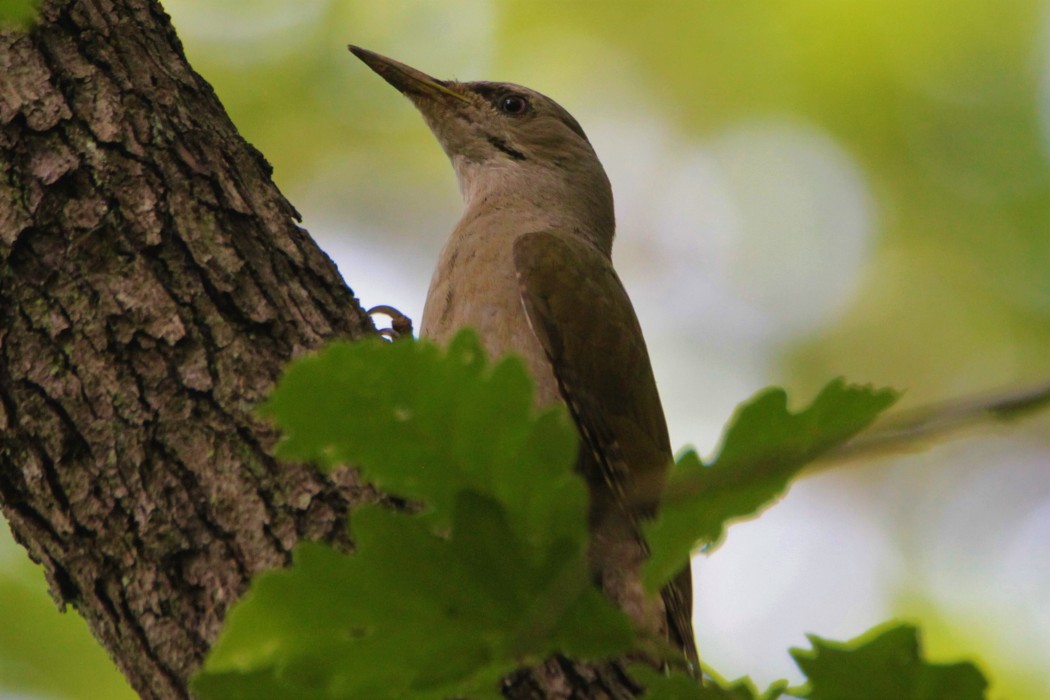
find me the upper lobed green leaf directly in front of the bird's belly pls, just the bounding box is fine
[261,331,587,543]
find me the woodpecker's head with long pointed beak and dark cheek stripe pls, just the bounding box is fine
[350,46,612,243]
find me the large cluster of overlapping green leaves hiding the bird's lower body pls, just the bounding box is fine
[193,332,633,700]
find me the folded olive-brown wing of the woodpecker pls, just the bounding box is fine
[513,231,696,662]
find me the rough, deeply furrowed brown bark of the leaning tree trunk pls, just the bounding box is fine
[0,0,635,698]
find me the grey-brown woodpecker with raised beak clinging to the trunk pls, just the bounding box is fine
[349,45,697,670]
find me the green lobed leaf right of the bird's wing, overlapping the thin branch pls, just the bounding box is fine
[645,379,897,590]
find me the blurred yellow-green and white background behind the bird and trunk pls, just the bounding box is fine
[0,0,1050,698]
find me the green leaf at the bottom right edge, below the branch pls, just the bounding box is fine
[791,622,988,700]
